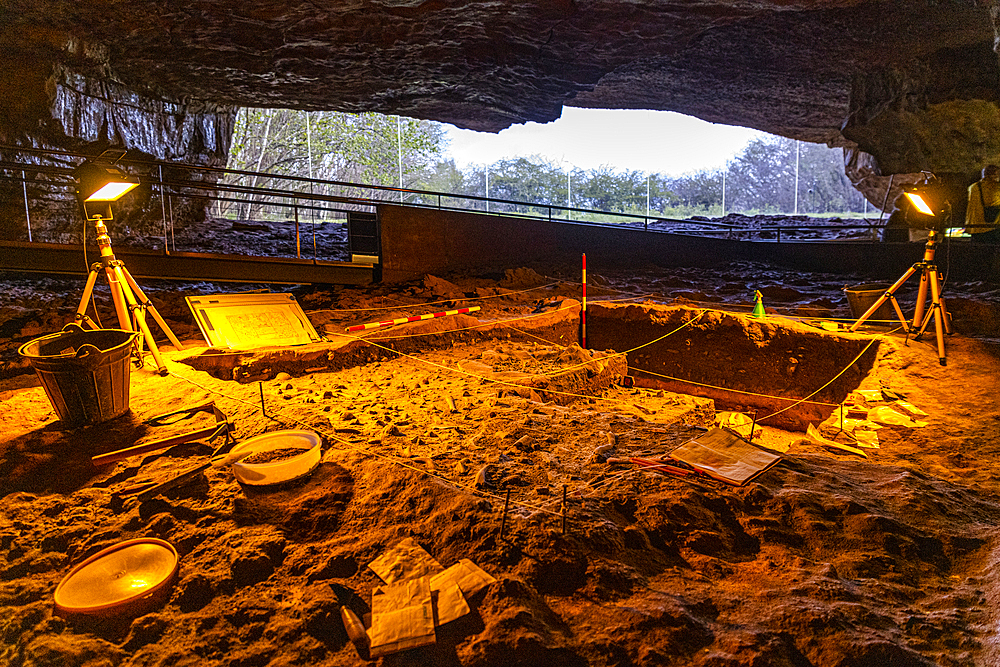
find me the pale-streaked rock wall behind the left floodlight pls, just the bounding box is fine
[0,56,236,243]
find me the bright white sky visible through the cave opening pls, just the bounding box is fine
[444,107,770,176]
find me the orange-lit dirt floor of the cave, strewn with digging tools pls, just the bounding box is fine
[0,265,1000,667]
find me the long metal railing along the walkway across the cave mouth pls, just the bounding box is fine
[0,146,882,259]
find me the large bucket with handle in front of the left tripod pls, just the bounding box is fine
[17,324,139,426]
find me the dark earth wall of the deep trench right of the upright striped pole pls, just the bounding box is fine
[587,304,878,430]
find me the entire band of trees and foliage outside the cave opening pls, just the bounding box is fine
[220,109,864,220]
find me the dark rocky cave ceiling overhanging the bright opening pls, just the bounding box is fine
[0,0,1000,183]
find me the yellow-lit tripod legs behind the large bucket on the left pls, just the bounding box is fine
[74,215,183,375]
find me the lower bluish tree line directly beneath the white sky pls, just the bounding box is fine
[410,137,865,220]
